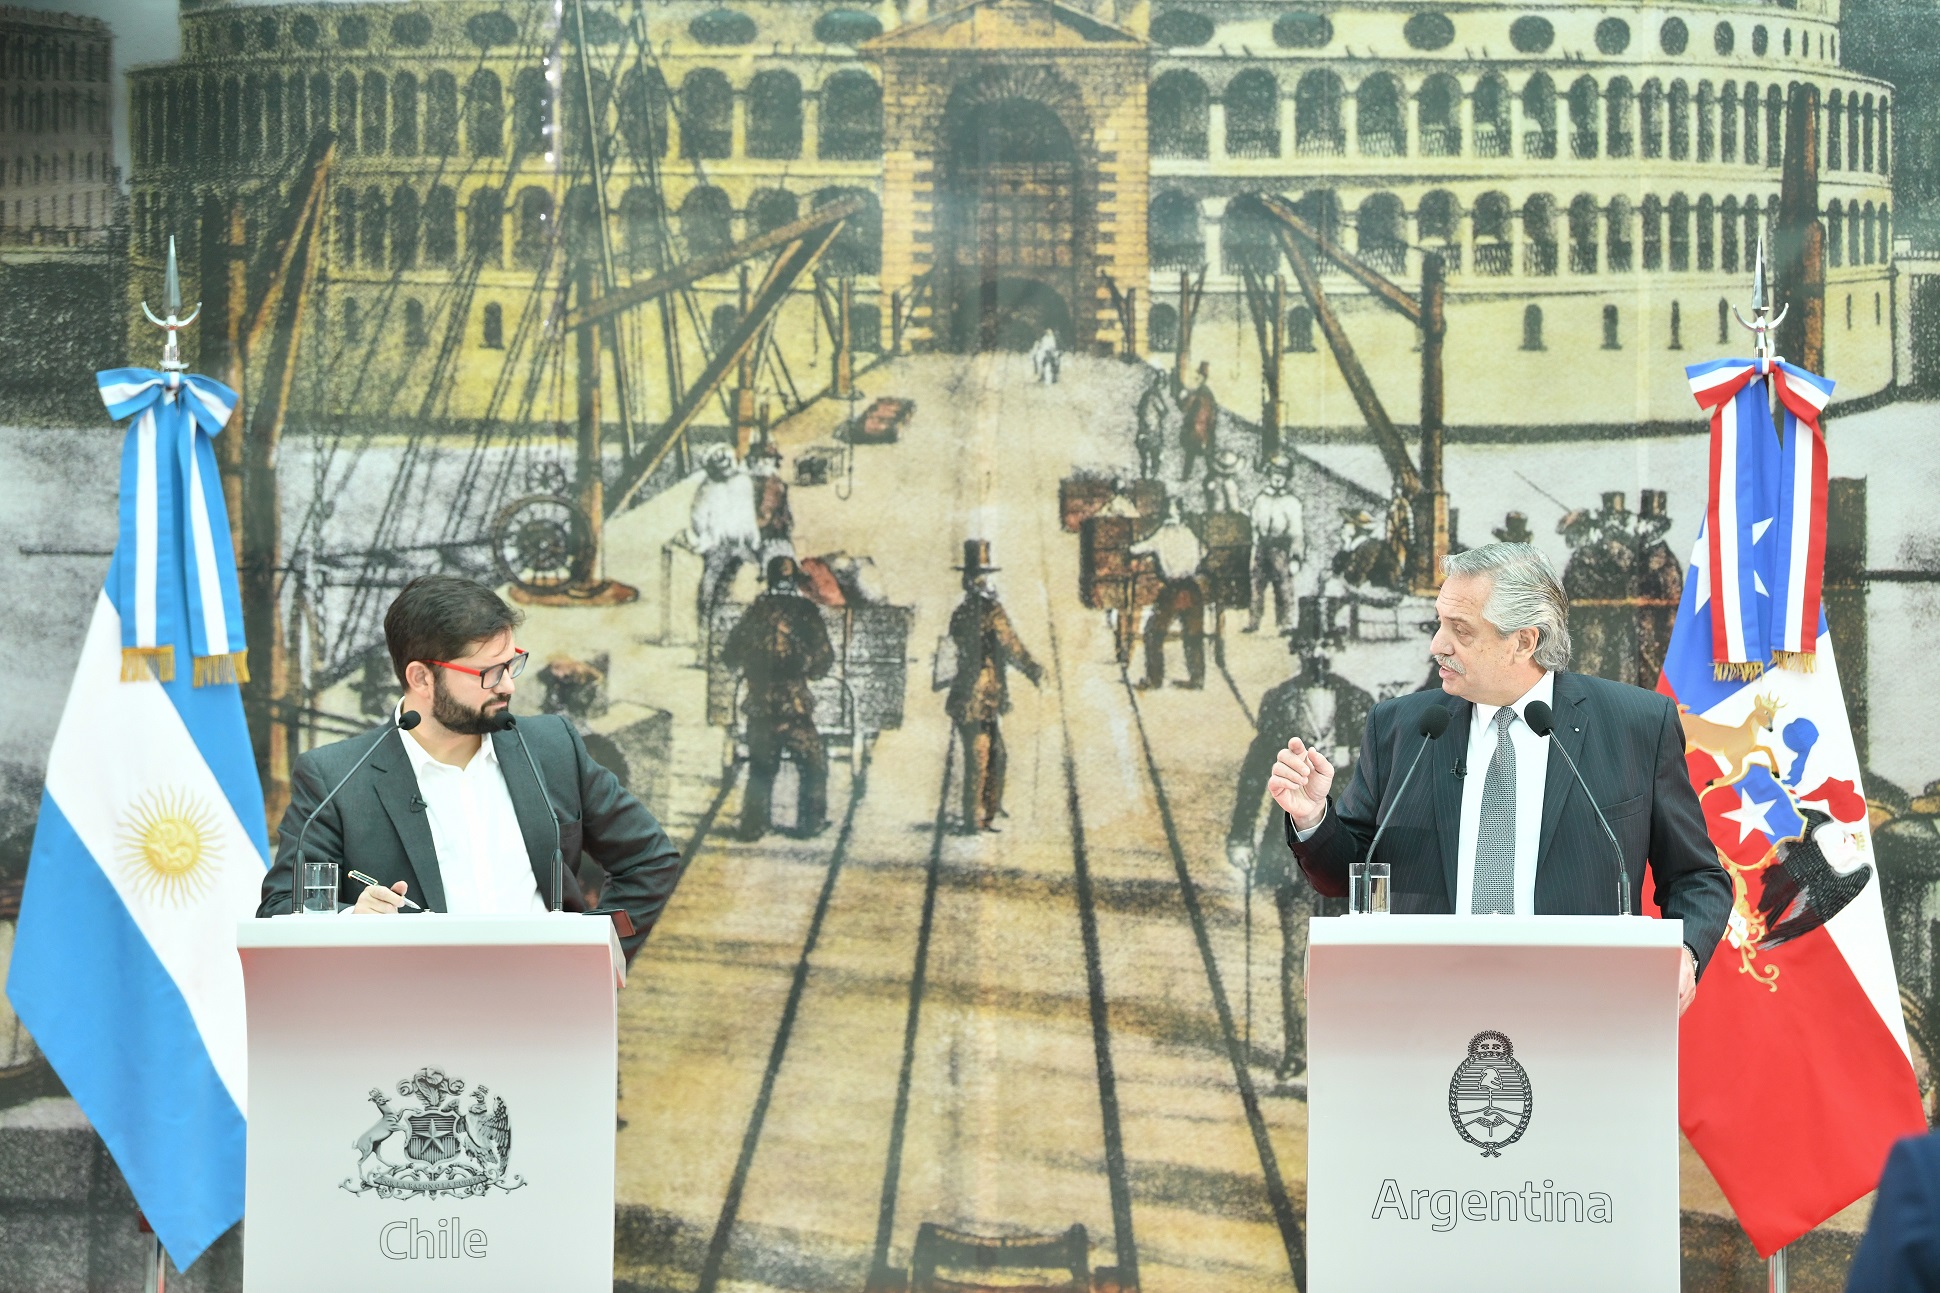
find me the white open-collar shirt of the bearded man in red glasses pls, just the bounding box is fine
[404,710,545,916]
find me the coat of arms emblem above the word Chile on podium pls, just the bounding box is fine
[341,1068,526,1198]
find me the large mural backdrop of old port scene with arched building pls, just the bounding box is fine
[0,0,1940,1293]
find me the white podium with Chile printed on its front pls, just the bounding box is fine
[237,914,625,1293]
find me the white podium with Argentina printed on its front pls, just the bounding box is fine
[1308,916,1684,1293]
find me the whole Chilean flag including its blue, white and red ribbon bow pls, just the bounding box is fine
[1657,359,1926,1256]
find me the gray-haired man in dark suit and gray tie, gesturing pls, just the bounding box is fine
[1267,544,1732,1011]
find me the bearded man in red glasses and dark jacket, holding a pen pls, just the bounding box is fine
[256,575,681,957]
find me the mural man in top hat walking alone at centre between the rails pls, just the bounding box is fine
[945,540,1044,833]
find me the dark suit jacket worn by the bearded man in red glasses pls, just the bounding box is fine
[256,714,681,961]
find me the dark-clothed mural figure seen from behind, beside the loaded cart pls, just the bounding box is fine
[722,557,836,839]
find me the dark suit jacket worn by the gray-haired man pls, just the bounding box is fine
[1286,674,1732,973]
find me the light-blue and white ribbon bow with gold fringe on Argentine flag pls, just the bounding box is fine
[95,369,248,687]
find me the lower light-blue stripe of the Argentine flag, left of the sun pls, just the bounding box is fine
[8,792,246,1270]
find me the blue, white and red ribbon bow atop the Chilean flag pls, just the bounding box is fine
[1686,359,1833,680]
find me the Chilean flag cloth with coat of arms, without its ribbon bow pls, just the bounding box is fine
[1659,493,1926,1256]
